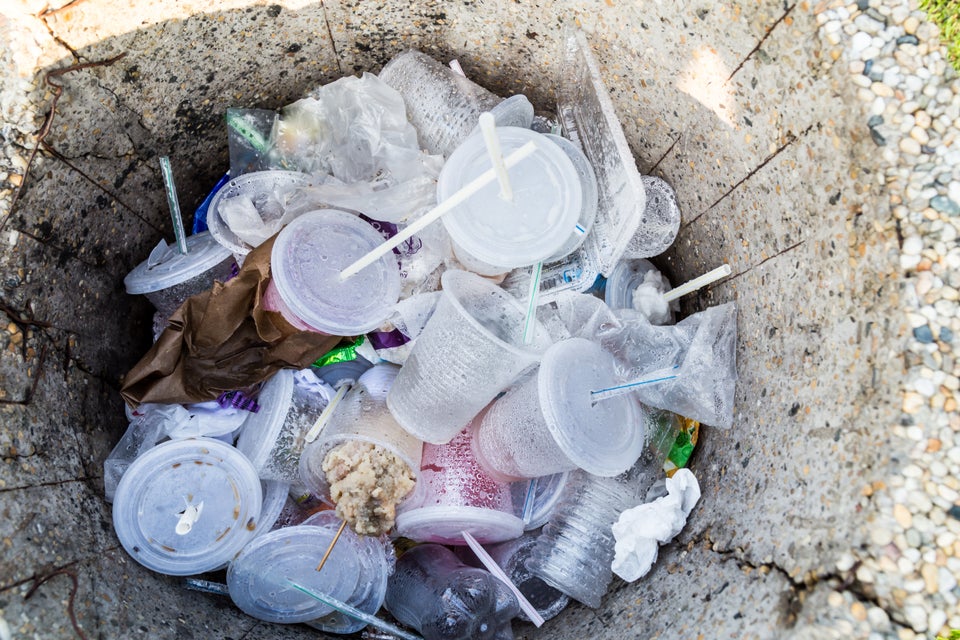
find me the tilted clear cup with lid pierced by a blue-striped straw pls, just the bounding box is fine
[474,338,645,480]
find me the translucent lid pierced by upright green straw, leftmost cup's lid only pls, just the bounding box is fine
[123,231,231,295]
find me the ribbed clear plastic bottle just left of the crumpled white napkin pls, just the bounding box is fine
[527,411,679,609]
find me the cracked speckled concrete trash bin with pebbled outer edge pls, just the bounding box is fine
[0,0,960,640]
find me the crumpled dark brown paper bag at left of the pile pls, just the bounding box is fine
[120,236,340,407]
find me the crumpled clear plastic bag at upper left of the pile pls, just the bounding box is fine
[271,73,443,223]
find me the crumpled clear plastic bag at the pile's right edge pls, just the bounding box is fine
[557,293,737,429]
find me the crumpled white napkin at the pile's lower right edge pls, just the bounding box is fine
[611,469,700,582]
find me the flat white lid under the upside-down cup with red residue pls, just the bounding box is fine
[395,506,523,545]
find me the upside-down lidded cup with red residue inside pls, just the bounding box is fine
[396,422,523,545]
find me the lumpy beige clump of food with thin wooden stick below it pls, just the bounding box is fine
[322,440,416,536]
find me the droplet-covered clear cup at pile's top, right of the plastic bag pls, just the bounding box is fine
[379,49,533,157]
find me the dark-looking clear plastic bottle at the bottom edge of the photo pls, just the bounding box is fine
[384,544,520,640]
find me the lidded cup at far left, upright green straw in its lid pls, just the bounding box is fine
[123,231,236,319]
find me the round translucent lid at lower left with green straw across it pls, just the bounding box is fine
[227,525,361,623]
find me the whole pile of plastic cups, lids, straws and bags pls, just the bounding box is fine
[105,34,736,640]
